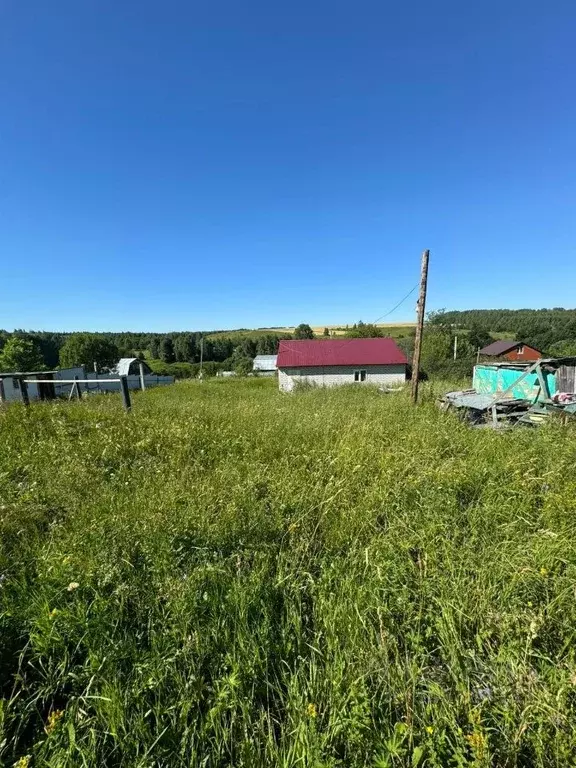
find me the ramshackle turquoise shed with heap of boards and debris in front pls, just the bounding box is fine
[439,357,576,429]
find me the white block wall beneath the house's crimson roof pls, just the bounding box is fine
[278,365,406,392]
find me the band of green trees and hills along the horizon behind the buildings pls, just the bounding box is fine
[0,308,576,378]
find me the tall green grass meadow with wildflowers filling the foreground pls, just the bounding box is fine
[0,380,576,768]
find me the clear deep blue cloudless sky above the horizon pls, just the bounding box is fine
[0,0,576,331]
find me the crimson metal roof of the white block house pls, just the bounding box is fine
[277,339,408,368]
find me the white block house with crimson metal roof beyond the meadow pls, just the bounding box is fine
[277,339,408,392]
